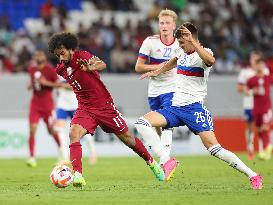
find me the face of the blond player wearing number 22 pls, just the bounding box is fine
[158,16,176,36]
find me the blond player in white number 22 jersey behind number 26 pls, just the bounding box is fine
[135,9,179,162]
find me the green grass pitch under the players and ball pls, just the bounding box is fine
[0,155,273,205]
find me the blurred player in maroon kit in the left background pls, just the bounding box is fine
[27,51,60,167]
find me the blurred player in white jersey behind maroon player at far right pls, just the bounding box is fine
[237,51,268,160]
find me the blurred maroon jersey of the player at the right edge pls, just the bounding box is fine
[247,76,273,115]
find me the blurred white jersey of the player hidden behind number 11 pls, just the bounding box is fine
[57,76,78,111]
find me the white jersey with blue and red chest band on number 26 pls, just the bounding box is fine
[172,48,213,106]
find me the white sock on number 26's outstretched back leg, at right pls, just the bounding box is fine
[208,144,257,178]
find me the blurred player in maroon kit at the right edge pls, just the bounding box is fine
[246,59,273,160]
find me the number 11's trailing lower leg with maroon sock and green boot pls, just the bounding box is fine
[116,131,165,181]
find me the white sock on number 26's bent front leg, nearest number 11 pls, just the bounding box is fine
[135,117,170,164]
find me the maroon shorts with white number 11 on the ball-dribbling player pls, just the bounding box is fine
[71,103,128,135]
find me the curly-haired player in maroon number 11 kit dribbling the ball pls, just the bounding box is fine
[48,33,165,187]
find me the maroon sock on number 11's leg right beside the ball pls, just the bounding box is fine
[69,142,82,173]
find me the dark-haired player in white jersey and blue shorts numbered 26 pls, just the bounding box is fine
[136,23,262,189]
